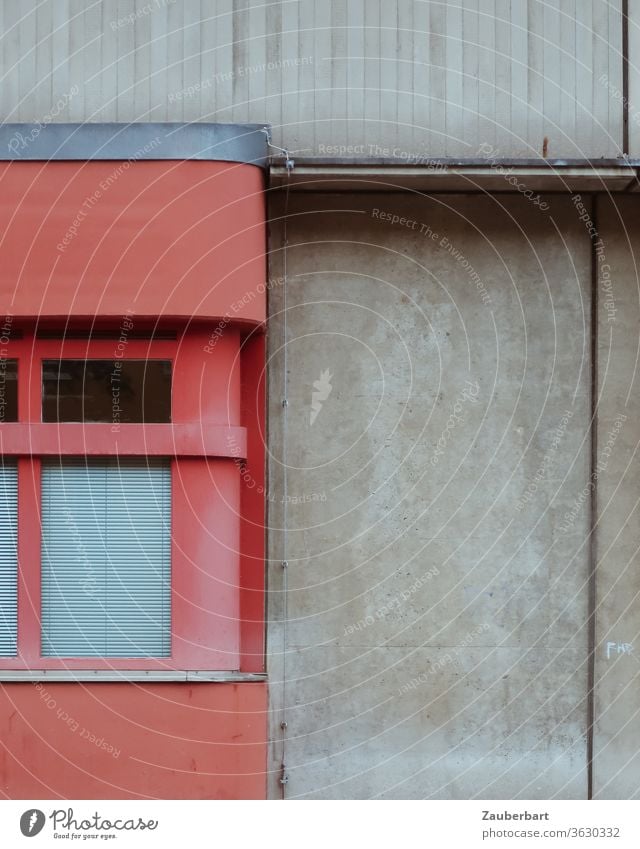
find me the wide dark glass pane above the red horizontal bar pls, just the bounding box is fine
[42,359,171,425]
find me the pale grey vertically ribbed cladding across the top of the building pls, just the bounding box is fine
[0,0,624,157]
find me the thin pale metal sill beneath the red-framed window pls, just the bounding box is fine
[0,669,267,684]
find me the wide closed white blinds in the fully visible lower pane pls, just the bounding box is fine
[42,458,171,657]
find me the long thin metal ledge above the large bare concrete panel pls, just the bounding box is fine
[270,158,640,194]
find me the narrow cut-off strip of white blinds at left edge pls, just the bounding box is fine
[0,461,18,657]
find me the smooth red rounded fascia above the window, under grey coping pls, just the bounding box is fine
[0,161,266,327]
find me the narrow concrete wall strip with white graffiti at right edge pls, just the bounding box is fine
[592,198,640,799]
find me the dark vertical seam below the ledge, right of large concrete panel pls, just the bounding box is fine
[587,194,600,799]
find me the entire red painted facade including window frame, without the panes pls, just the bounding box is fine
[0,161,266,799]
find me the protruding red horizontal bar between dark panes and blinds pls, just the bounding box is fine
[0,422,247,459]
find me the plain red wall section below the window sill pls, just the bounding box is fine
[0,681,266,799]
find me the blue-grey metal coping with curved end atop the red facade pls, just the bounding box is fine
[0,122,269,168]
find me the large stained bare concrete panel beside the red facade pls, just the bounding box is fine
[268,194,590,798]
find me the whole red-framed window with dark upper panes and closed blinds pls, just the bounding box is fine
[0,326,252,679]
